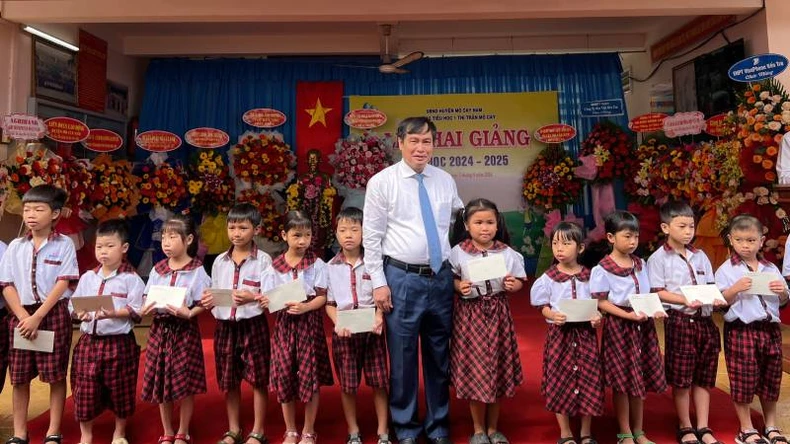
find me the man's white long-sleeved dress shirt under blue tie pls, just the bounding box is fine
[362,160,464,288]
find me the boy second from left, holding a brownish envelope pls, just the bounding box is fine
[71,219,145,444]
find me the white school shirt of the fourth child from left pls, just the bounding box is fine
[211,246,272,321]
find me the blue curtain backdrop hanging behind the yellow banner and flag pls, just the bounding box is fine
[136,53,627,268]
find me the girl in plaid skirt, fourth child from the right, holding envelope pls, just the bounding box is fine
[530,222,603,444]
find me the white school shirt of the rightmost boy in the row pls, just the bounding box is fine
[716,254,787,324]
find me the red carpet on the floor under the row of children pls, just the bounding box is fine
[30,293,760,444]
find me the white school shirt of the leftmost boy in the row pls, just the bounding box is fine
[0,231,80,305]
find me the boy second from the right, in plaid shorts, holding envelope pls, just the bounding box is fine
[647,201,726,444]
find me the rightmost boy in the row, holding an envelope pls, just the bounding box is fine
[716,215,788,444]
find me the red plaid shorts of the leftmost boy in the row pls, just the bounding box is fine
[7,299,72,385]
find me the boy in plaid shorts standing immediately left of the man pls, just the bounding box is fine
[326,207,390,444]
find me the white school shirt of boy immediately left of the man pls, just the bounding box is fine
[326,251,376,311]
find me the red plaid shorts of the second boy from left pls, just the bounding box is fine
[71,332,140,422]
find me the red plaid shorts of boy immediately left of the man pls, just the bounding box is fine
[332,333,389,393]
